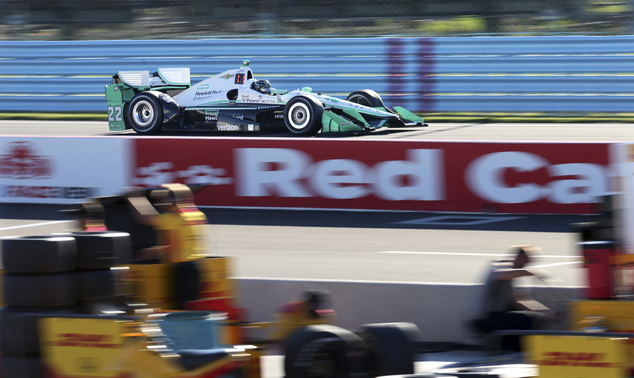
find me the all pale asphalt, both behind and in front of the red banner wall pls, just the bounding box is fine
[0,121,634,286]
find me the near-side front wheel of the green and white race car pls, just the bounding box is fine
[284,96,324,135]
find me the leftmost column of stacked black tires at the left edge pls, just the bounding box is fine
[0,236,78,378]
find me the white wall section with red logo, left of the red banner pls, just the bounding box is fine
[0,137,134,204]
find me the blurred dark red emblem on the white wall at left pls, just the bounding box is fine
[0,142,53,179]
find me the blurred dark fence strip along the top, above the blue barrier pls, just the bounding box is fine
[0,0,634,40]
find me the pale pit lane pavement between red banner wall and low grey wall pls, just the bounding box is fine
[0,205,589,286]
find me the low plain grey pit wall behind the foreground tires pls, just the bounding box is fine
[237,278,578,344]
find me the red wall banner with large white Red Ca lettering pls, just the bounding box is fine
[132,138,610,214]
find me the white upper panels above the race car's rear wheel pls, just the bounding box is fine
[112,68,191,88]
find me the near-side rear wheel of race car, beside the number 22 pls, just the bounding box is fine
[127,92,163,134]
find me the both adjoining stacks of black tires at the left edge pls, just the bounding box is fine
[0,231,131,378]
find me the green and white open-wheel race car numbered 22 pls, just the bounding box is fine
[106,61,427,135]
